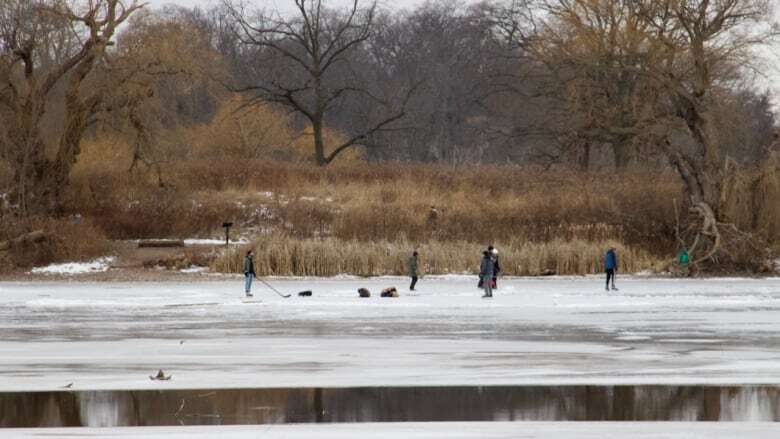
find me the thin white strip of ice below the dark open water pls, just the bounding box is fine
[2,422,778,439]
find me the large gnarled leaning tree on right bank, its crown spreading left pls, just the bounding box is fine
[541,0,777,262]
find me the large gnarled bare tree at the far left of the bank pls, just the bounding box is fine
[0,0,142,213]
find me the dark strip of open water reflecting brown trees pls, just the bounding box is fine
[0,386,780,427]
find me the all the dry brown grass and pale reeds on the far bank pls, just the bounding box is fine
[6,145,780,275]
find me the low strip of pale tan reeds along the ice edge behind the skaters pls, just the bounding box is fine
[210,235,663,276]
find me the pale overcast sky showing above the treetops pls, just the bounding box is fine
[146,0,780,101]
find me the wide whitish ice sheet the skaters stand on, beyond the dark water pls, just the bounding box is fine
[0,276,780,391]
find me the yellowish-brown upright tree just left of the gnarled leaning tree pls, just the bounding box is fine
[529,0,657,169]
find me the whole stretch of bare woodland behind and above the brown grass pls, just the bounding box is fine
[0,0,780,274]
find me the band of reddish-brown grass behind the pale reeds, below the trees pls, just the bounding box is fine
[65,160,682,252]
